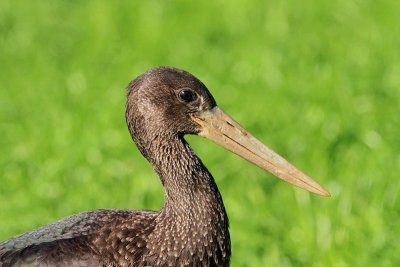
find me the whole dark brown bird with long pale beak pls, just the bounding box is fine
[0,67,330,267]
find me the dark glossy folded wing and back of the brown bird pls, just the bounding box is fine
[0,209,156,266]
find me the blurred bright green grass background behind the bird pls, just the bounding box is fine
[0,0,400,266]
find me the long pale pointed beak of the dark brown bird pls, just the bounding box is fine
[192,107,330,196]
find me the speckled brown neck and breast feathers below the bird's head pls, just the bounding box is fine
[141,138,230,266]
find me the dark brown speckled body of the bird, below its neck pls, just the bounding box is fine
[0,210,229,267]
